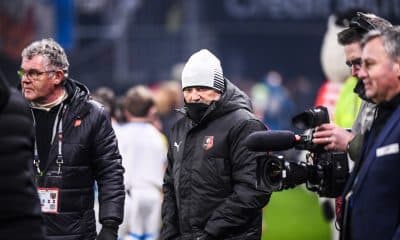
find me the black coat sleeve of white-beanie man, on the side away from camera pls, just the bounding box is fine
[160,148,180,240]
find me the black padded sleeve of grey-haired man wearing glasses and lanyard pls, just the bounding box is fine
[93,110,125,223]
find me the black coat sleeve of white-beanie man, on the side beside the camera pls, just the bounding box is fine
[205,120,270,237]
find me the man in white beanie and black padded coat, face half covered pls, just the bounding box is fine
[161,49,270,240]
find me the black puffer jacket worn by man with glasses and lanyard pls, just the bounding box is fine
[37,79,125,240]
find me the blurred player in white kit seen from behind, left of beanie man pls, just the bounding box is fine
[117,86,167,240]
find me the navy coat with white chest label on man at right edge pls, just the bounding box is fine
[341,107,400,240]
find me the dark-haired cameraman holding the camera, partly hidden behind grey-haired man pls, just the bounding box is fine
[313,13,392,158]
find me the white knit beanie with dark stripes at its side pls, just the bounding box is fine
[182,49,225,93]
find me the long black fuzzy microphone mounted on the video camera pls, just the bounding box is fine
[245,130,300,152]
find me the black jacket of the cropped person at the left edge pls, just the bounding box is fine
[0,89,44,240]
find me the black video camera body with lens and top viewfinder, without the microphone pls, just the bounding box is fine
[257,107,349,198]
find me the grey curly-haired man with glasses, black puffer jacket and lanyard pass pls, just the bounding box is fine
[18,39,125,240]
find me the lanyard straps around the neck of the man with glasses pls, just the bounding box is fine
[32,104,67,176]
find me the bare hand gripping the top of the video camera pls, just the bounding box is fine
[313,123,354,152]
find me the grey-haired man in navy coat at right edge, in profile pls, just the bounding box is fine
[342,27,400,240]
